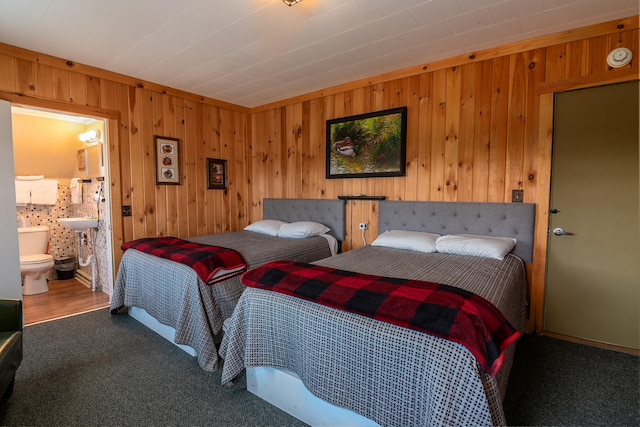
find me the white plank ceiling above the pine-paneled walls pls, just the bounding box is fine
[0,0,639,108]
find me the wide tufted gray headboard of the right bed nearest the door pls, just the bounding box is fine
[378,201,536,263]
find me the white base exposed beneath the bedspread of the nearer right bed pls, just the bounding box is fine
[247,367,380,427]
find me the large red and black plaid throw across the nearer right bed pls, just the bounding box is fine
[242,261,520,376]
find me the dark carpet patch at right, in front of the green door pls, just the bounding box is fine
[504,336,640,426]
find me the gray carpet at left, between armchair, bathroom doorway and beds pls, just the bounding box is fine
[0,309,304,426]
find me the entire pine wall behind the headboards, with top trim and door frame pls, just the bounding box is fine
[249,17,640,332]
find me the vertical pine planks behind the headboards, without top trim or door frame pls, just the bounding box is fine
[250,57,545,248]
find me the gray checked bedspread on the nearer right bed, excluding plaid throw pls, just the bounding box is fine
[220,246,526,426]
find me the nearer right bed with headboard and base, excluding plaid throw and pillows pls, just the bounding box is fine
[220,201,535,426]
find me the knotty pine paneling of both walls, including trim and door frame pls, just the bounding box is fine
[0,16,640,331]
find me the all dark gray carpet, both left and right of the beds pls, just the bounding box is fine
[0,309,640,426]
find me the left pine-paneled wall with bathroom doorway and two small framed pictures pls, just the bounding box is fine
[0,44,250,274]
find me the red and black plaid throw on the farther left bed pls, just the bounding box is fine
[122,237,247,285]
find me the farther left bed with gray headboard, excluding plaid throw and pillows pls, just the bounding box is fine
[111,199,345,371]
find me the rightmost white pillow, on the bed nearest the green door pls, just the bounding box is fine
[436,234,516,259]
